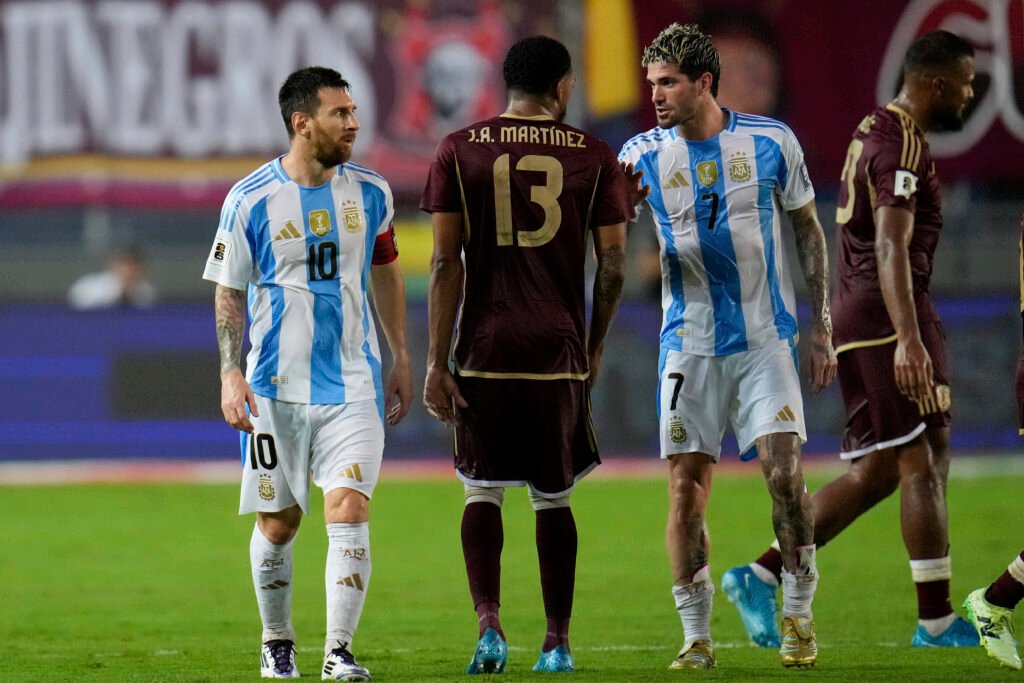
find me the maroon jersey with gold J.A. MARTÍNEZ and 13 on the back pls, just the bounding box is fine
[420,117,632,379]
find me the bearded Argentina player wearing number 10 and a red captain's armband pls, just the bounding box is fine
[203,67,413,681]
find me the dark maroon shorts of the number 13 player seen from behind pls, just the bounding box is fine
[455,377,601,496]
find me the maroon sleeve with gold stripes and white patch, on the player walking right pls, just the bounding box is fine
[864,121,924,213]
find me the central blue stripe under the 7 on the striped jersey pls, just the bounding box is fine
[686,136,748,355]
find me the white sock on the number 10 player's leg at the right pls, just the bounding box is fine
[324,522,370,652]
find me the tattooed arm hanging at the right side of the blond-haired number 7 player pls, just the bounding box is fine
[790,200,838,393]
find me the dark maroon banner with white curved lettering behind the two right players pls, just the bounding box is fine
[634,0,1011,187]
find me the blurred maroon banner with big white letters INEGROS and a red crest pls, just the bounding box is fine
[0,0,558,208]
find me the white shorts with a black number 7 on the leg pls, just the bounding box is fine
[657,340,807,462]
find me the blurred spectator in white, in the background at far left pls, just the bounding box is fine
[68,246,157,310]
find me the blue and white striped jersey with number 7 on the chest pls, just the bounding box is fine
[618,110,814,355]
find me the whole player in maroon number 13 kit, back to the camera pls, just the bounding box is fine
[420,36,632,674]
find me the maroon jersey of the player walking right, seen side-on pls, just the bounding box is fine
[833,104,942,348]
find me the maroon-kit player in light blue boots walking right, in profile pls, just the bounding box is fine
[723,31,978,647]
